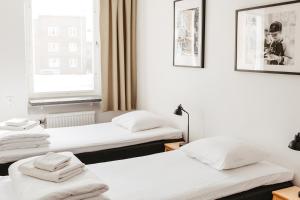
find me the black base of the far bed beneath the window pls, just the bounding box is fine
[0,139,182,176]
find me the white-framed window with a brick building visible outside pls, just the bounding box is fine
[26,0,100,98]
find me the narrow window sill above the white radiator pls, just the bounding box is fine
[29,96,101,106]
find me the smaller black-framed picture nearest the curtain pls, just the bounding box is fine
[173,0,205,68]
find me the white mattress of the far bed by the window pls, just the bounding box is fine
[0,123,182,164]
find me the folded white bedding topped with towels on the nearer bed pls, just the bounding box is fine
[9,152,108,200]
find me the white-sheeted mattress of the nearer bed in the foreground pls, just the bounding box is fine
[0,150,293,200]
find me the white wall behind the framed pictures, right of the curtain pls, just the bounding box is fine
[138,0,300,184]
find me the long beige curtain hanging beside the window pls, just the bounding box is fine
[100,0,137,111]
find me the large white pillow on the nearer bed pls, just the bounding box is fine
[181,137,266,170]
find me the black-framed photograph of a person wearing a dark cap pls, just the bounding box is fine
[235,0,300,75]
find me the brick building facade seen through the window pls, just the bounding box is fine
[34,16,93,75]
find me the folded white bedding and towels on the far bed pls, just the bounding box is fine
[0,119,49,151]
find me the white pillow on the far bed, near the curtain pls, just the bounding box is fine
[112,111,164,132]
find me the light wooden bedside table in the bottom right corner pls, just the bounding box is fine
[272,186,300,200]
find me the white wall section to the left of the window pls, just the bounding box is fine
[0,0,27,120]
